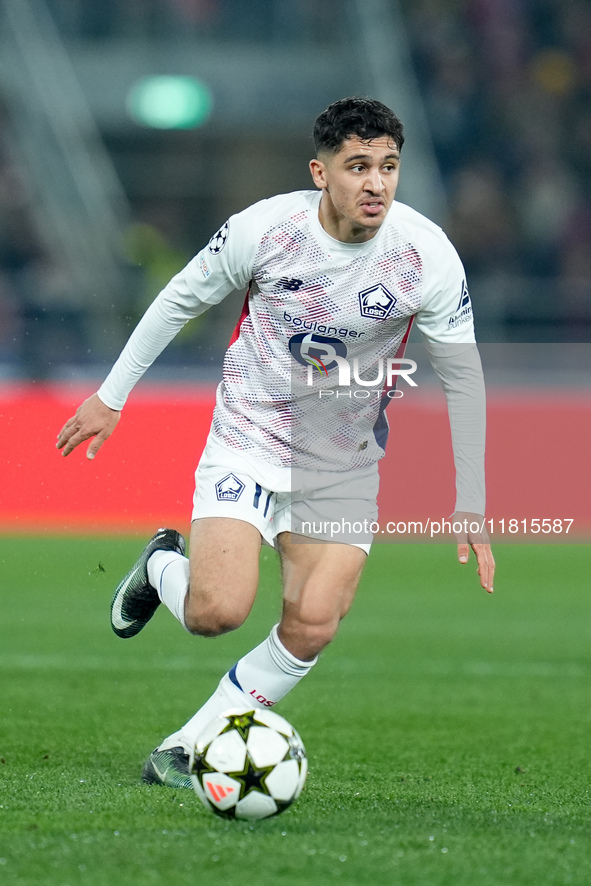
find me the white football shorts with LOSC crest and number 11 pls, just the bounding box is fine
[192,434,379,553]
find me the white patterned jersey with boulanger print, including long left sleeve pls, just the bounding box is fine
[99,191,474,470]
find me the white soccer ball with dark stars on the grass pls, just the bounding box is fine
[189,708,308,821]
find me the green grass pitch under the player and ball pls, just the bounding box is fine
[0,537,591,886]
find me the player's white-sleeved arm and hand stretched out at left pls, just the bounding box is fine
[57,204,261,459]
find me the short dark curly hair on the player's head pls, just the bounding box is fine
[314,97,404,154]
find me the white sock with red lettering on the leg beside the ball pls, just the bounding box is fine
[160,625,318,753]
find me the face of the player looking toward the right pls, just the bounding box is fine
[310,135,400,243]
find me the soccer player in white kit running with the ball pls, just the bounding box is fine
[57,98,494,787]
